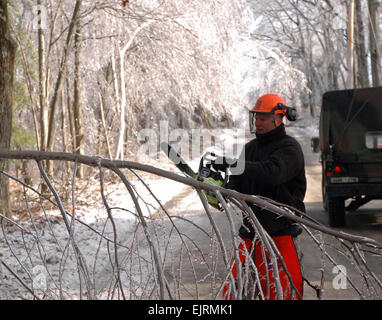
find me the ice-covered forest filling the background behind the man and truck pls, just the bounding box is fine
[0,0,381,218]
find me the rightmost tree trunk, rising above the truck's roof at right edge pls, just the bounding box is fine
[367,0,381,87]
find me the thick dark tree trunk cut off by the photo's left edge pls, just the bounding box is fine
[0,0,16,216]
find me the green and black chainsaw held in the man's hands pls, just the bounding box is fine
[161,142,228,211]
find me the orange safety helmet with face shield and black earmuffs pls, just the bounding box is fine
[249,93,297,133]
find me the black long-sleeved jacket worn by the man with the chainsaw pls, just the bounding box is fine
[229,124,306,239]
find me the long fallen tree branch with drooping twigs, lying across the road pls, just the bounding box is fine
[0,150,382,299]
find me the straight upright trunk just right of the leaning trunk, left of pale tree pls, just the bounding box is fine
[73,21,84,178]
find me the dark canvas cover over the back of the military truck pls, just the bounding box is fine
[320,87,382,163]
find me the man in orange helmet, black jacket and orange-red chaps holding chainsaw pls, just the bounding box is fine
[217,94,306,300]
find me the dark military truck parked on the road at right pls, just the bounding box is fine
[311,87,382,227]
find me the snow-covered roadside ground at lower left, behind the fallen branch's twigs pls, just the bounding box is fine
[0,171,192,299]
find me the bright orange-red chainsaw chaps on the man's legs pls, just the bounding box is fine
[223,235,303,300]
